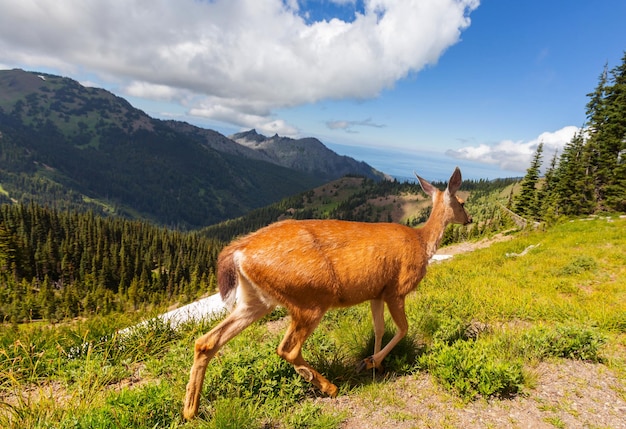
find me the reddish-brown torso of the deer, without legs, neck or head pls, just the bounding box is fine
[228,220,428,307]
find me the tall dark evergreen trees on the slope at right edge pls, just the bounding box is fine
[513,52,626,221]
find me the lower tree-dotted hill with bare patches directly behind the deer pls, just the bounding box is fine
[202,176,516,243]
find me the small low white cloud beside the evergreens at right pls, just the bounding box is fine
[446,126,580,172]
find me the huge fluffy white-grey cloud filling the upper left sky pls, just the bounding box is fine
[0,0,478,129]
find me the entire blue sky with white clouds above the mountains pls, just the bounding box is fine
[0,0,626,179]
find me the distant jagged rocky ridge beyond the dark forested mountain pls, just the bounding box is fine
[230,129,389,180]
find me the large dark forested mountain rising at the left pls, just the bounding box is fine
[0,70,382,228]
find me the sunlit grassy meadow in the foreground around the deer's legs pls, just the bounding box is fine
[0,218,626,428]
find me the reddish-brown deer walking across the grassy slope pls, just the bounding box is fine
[183,167,472,420]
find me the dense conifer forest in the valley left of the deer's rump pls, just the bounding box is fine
[0,204,223,322]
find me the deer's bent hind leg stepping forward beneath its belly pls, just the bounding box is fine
[277,311,337,397]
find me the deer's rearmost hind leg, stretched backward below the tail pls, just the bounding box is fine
[183,280,275,420]
